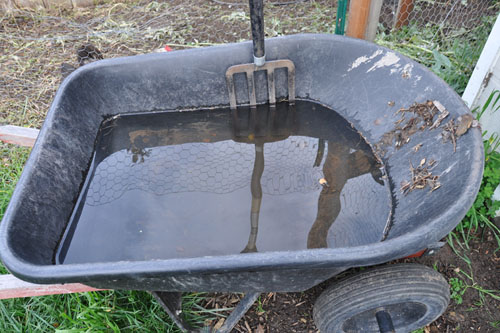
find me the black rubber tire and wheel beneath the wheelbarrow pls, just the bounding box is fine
[313,264,450,333]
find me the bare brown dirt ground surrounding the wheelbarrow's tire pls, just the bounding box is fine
[207,224,500,333]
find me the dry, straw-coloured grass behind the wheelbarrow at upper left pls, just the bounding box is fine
[0,0,335,127]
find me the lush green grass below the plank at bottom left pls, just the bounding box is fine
[0,291,222,332]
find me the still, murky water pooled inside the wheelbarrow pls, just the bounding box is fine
[55,101,392,264]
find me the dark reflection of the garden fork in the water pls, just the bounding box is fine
[231,103,295,253]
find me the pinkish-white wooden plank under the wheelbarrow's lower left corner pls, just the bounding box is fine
[0,274,105,299]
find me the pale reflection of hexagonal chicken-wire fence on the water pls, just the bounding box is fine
[86,137,323,205]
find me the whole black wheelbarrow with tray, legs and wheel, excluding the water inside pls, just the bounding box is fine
[0,10,484,332]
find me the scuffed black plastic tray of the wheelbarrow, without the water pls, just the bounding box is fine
[0,35,483,331]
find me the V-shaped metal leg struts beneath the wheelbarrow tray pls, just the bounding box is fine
[151,291,261,333]
